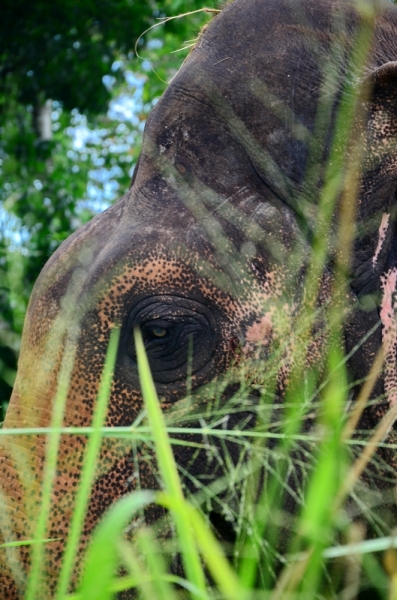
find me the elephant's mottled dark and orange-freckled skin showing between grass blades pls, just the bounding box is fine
[0,0,397,599]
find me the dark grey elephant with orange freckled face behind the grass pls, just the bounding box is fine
[0,0,397,600]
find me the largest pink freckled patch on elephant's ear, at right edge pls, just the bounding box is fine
[380,267,397,406]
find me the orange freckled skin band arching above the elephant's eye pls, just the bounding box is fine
[93,253,283,326]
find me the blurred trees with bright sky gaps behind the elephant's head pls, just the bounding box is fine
[0,0,218,418]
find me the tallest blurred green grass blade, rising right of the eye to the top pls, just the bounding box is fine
[258,1,376,595]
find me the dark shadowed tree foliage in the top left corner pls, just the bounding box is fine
[0,0,153,114]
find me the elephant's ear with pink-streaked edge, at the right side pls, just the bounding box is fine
[346,61,397,410]
